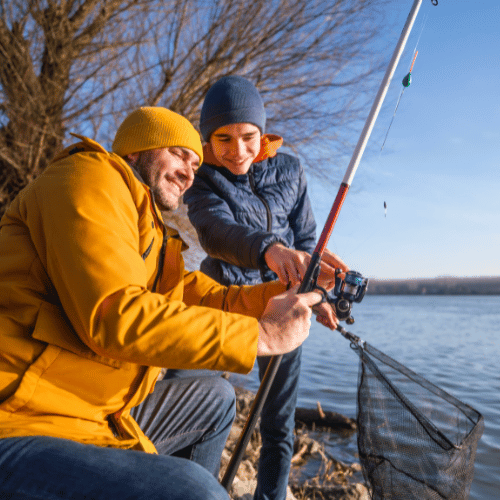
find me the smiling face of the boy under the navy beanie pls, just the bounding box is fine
[210,123,261,175]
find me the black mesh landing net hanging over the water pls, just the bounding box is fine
[352,343,484,500]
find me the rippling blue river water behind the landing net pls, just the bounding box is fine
[231,295,500,500]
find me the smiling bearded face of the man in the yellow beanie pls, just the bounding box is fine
[135,146,200,210]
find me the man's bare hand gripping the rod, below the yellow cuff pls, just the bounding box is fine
[257,285,321,356]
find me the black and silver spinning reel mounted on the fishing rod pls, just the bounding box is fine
[326,269,368,325]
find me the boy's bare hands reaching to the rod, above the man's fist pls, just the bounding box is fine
[264,243,349,290]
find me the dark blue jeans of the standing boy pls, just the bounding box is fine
[166,347,302,500]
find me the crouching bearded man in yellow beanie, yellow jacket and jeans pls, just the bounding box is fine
[0,107,337,500]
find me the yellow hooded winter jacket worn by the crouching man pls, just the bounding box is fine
[0,137,284,452]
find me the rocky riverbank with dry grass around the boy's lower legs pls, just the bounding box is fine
[220,387,369,500]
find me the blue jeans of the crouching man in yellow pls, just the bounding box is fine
[0,377,235,500]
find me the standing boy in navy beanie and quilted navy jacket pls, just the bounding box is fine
[184,76,347,500]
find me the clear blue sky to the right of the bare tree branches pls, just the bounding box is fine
[308,0,500,279]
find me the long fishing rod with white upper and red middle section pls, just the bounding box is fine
[221,0,438,491]
